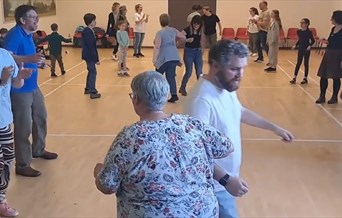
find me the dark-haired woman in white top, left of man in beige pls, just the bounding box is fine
[247,7,259,57]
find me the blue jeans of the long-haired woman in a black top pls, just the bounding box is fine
[180,47,203,90]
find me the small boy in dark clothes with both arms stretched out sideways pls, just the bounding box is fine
[36,23,72,77]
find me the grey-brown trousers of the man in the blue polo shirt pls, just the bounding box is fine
[11,88,47,168]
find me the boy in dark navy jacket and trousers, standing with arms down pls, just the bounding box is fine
[82,13,101,99]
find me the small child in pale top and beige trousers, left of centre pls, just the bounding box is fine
[116,20,129,76]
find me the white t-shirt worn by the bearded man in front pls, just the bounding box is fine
[185,78,242,192]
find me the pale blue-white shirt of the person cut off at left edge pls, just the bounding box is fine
[0,48,18,128]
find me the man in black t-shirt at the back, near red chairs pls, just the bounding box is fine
[202,6,222,48]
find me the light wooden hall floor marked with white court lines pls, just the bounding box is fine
[8,48,342,218]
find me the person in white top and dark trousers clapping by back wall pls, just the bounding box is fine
[133,4,149,58]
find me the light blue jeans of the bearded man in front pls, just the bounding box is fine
[215,191,239,218]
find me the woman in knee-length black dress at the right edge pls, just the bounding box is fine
[316,11,342,104]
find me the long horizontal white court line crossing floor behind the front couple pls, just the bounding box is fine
[48,133,342,143]
